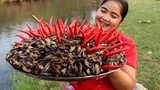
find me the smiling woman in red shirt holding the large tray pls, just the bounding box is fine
[71,0,137,90]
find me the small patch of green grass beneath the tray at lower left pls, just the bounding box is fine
[11,71,68,90]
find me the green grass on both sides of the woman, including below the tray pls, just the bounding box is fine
[9,0,160,90]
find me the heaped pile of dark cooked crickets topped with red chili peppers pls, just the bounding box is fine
[6,17,128,77]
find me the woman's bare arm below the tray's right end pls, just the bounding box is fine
[108,65,136,90]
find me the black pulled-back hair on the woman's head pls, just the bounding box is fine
[100,0,128,21]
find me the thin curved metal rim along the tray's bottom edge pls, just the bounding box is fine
[18,68,119,81]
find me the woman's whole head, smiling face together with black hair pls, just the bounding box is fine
[96,0,128,30]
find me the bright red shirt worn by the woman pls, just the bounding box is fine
[72,34,137,90]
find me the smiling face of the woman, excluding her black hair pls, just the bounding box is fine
[95,1,122,31]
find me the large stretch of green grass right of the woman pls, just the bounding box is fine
[122,0,160,90]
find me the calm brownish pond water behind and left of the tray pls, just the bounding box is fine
[0,0,101,90]
